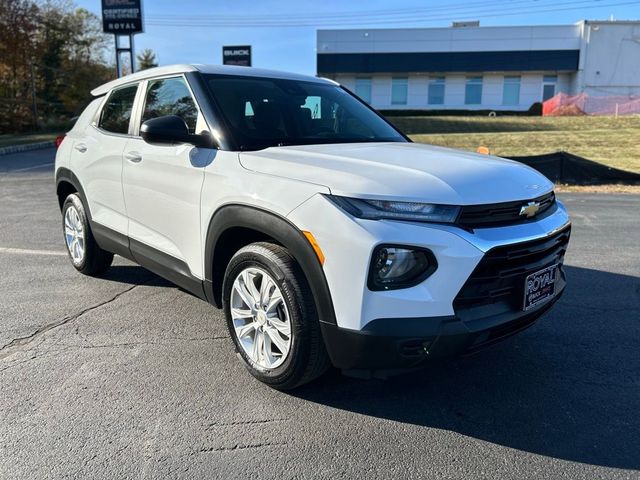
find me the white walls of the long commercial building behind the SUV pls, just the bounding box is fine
[318,21,640,110]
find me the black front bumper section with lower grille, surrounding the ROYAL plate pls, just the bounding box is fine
[322,226,571,370]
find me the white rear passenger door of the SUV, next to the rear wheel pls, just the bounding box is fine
[70,84,138,235]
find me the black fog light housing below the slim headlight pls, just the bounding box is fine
[367,245,438,291]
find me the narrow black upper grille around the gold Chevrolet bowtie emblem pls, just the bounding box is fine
[456,192,556,228]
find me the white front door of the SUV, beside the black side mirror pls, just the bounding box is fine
[123,75,215,281]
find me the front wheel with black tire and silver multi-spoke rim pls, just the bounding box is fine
[222,242,330,390]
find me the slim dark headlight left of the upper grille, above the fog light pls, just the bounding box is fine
[327,195,460,223]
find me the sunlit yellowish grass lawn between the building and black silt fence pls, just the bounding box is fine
[389,116,640,173]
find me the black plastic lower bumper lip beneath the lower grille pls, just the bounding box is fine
[321,288,564,371]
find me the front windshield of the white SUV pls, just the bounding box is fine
[205,75,406,150]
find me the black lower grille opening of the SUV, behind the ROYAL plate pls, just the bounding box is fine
[453,227,571,321]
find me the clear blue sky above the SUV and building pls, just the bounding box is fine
[76,0,640,74]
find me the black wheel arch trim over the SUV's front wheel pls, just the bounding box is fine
[204,204,336,324]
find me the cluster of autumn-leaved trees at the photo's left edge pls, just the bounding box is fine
[0,0,115,133]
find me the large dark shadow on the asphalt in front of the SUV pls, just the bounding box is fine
[293,267,640,470]
